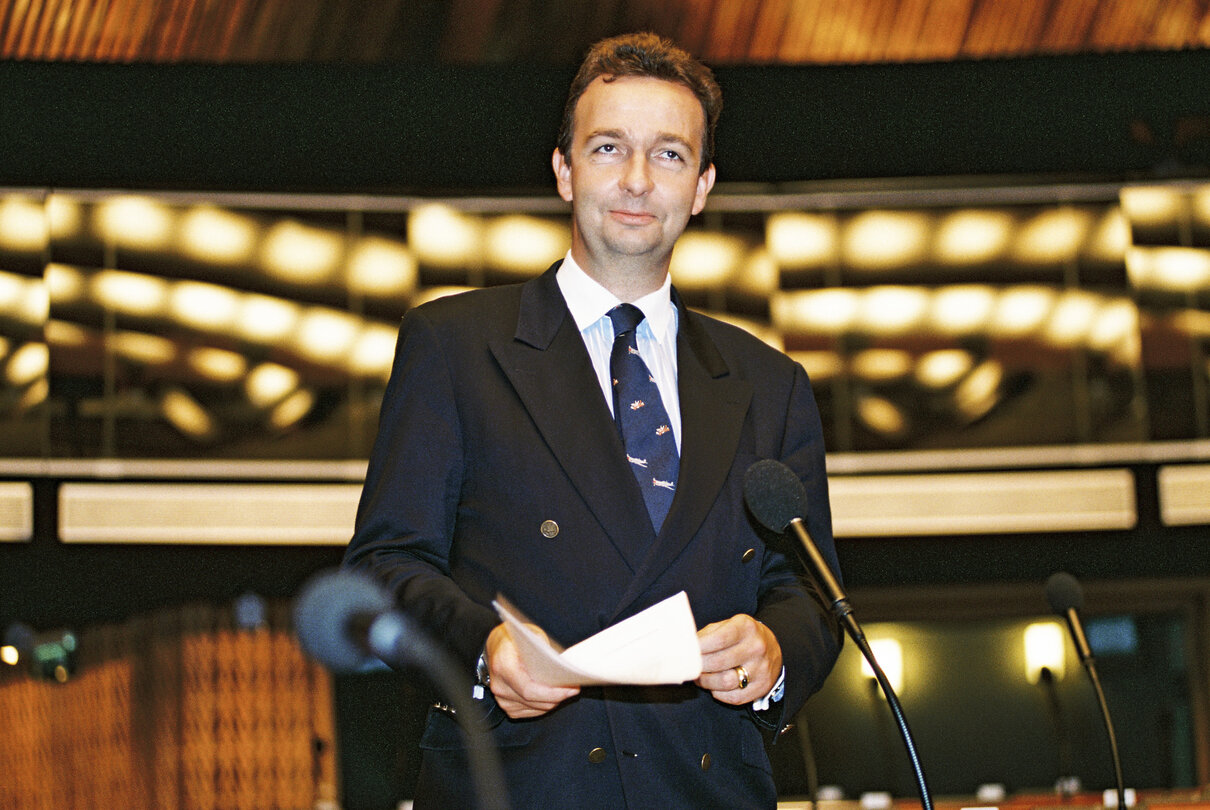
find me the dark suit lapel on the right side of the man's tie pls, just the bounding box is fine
[615,296,753,617]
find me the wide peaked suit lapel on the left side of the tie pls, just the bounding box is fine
[491,265,652,569]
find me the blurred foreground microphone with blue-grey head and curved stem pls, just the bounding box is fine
[294,569,508,810]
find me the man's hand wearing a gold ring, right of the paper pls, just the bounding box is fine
[695,614,782,706]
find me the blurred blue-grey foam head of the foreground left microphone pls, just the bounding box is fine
[294,570,394,672]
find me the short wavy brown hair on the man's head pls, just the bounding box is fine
[558,34,722,173]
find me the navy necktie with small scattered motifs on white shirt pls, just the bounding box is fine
[609,304,680,534]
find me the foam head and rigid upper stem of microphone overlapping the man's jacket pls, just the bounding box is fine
[744,459,855,625]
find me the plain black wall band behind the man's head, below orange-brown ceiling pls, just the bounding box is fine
[0,51,1210,191]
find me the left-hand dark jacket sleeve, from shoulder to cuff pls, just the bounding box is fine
[344,310,499,667]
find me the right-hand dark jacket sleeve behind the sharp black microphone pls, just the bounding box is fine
[756,363,843,728]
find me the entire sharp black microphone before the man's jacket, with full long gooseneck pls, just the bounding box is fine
[744,459,934,810]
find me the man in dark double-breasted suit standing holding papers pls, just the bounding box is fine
[346,35,840,808]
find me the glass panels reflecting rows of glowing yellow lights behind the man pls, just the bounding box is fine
[0,184,1210,460]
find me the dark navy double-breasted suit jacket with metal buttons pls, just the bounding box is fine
[346,265,841,809]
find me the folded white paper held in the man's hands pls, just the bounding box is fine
[491,591,702,687]
